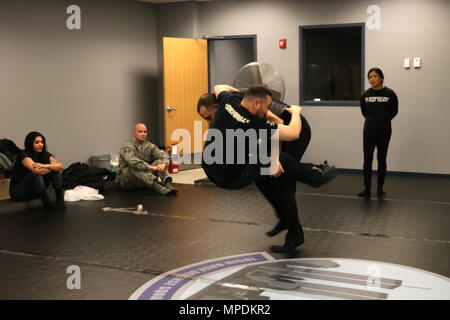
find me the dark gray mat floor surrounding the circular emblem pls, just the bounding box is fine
[0,174,450,299]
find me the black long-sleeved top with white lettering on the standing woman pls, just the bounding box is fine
[360,87,398,130]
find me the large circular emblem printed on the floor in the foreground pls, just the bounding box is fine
[129,252,450,300]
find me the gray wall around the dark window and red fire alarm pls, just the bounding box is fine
[162,0,450,174]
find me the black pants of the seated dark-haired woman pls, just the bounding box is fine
[9,172,63,205]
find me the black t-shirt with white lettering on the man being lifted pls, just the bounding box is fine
[202,91,278,189]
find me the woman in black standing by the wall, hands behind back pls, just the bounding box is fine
[358,68,398,197]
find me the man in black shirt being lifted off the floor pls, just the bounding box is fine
[198,85,336,189]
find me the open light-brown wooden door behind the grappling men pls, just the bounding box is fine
[163,38,208,153]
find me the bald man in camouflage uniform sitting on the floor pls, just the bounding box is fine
[116,123,177,195]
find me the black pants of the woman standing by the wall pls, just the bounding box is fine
[363,128,392,189]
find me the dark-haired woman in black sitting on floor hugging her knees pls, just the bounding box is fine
[9,131,65,210]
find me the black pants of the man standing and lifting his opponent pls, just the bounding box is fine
[255,112,317,246]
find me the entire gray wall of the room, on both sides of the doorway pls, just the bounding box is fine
[0,0,450,174]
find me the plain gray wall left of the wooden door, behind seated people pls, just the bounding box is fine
[0,0,159,166]
